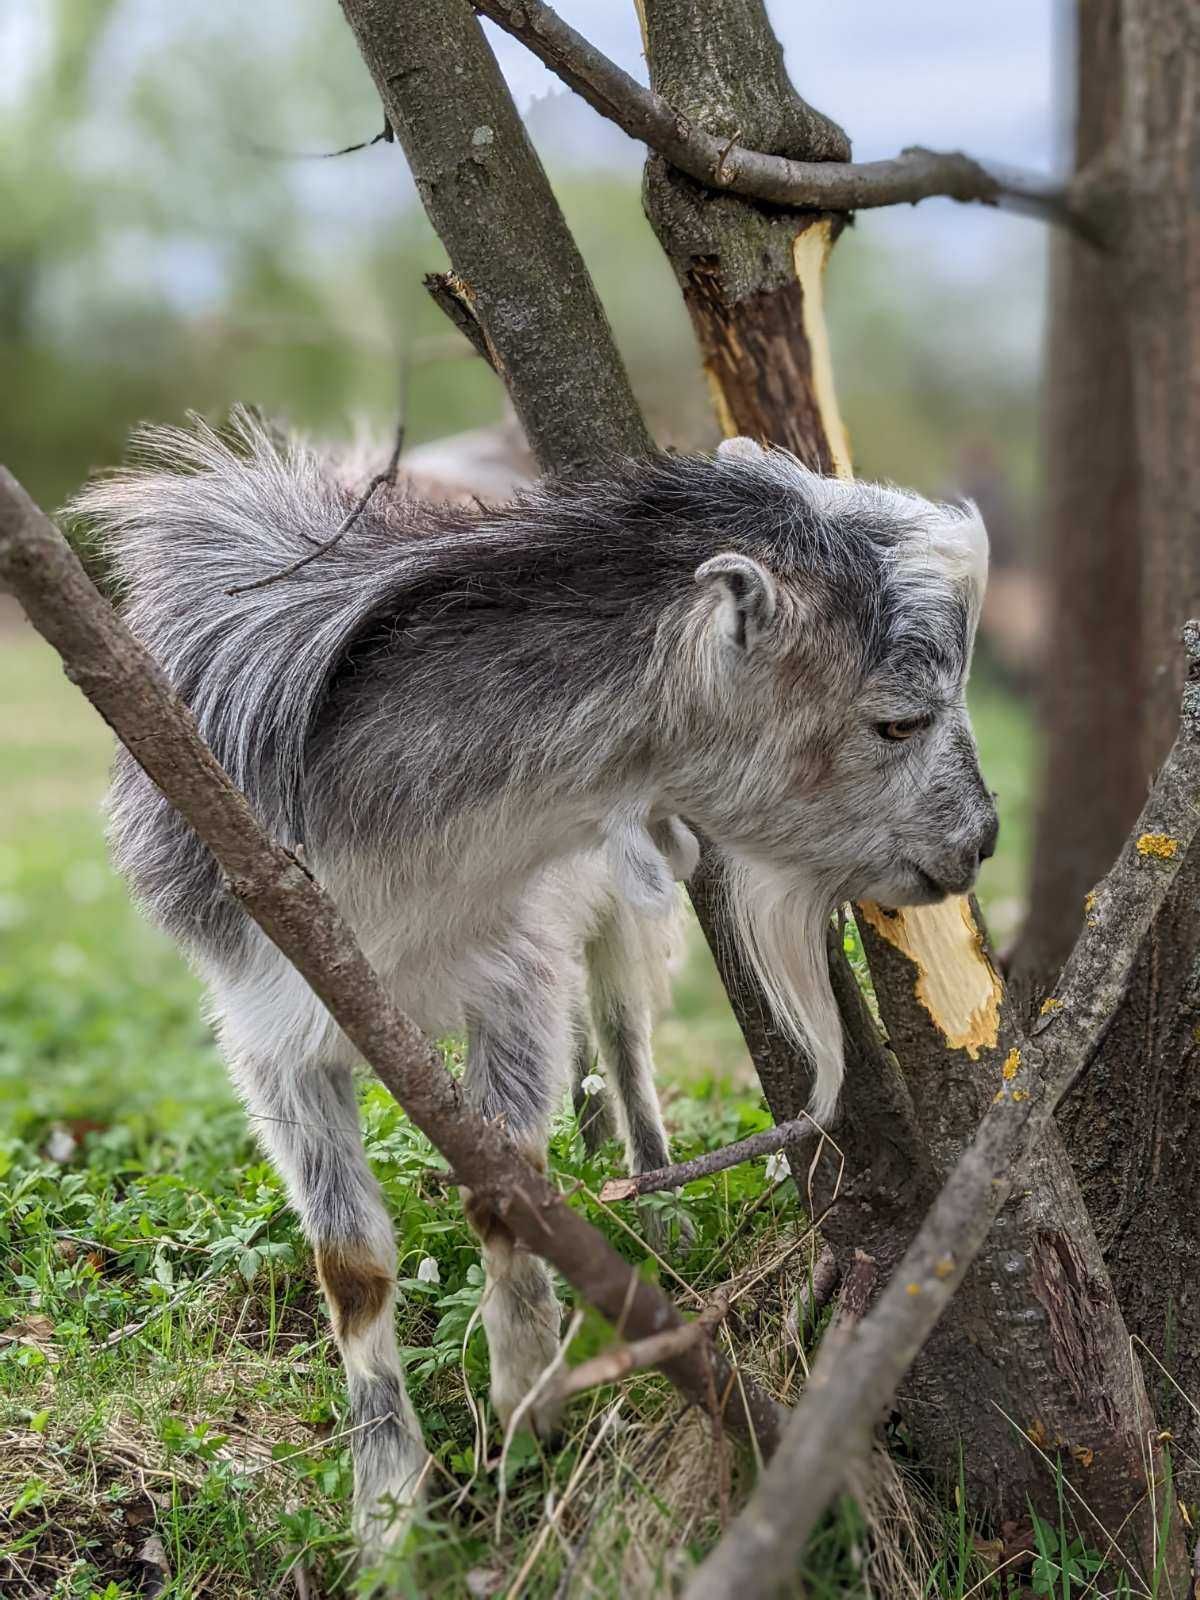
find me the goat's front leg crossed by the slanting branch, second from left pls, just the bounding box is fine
[462,979,571,1440]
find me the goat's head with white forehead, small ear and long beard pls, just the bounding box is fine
[652,440,997,1110]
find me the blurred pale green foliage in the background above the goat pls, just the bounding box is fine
[0,0,1040,531]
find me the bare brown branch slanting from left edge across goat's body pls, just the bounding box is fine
[0,467,790,1454]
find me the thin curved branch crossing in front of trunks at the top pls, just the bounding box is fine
[472,0,1088,232]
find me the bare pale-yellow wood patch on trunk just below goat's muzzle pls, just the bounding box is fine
[859,896,1003,1061]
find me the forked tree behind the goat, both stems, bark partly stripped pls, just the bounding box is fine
[342,0,1190,1574]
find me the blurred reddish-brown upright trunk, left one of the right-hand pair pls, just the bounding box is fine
[1010,0,1139,998]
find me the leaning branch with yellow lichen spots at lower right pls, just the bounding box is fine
[686,622,1200,1600]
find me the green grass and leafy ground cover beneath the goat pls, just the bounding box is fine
[0,619,1029,1600]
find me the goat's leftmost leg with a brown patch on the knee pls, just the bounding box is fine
[226,1016,429,1558]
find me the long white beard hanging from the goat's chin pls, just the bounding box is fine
[726,858,845,1126]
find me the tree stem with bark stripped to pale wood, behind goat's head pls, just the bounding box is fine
[642,0,1182,1570]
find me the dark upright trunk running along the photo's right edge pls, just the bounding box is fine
[1061,0,1200,1458]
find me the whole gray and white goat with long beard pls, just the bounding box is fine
[78,416,997,1550]
